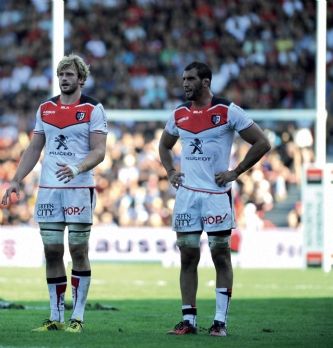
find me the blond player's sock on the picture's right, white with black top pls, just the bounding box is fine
[71,270,91,321]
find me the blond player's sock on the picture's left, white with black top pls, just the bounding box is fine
[46,276,67,323]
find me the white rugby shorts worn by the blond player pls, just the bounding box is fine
[34,188,96,224]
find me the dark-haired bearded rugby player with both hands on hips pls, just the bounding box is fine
[159,62,270,336]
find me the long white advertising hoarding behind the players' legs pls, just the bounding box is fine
[0,226,303,268]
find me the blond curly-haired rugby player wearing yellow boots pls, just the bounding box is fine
[2,55,107,333]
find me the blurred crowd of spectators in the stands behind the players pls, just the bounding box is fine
[0,0,333,227]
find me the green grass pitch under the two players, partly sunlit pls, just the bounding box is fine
[0,263,333,348]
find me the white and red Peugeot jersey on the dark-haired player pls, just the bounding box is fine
[165,97,253,193]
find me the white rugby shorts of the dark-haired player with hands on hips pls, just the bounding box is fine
[172,186,235,233]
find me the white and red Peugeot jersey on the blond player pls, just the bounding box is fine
[34,95,107,188]
